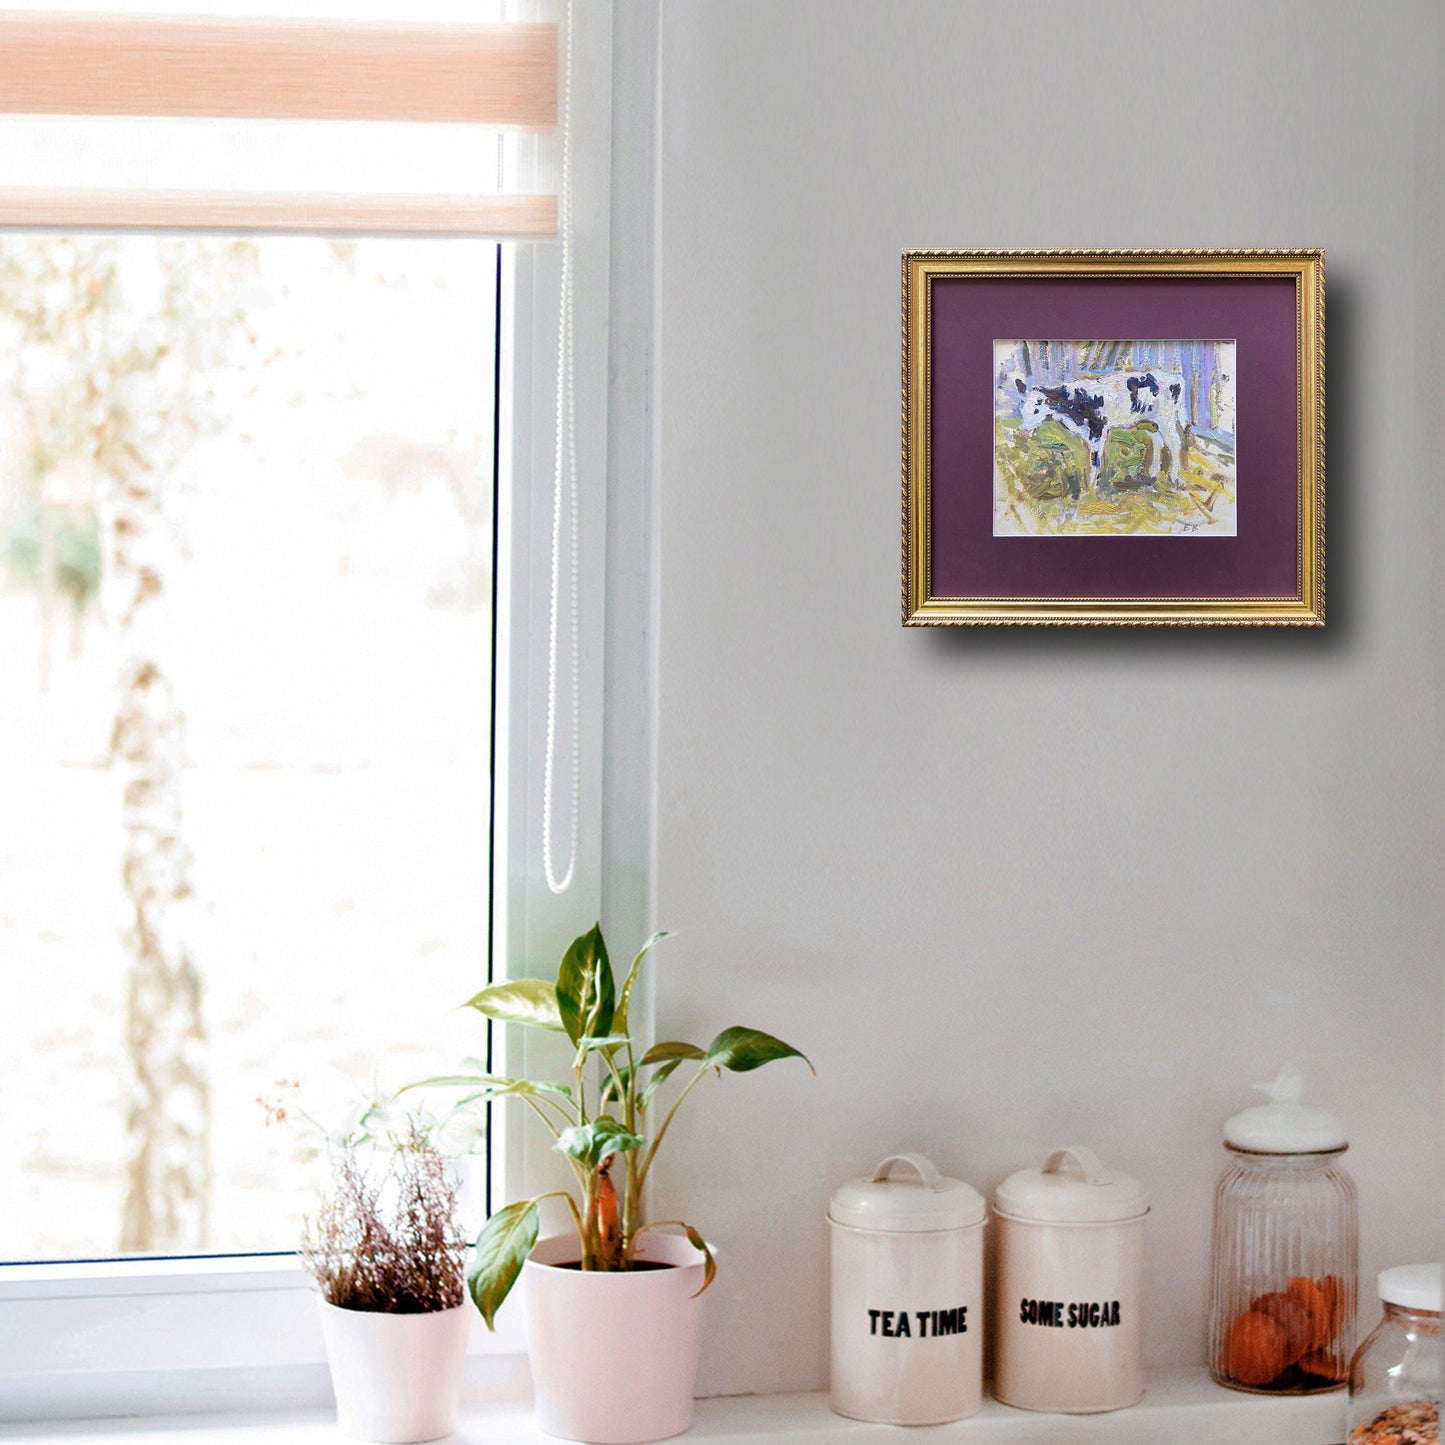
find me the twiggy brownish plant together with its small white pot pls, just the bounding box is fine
[299,1120,473,1442]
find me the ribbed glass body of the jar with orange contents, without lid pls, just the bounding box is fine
[1209,1144,1360,1394]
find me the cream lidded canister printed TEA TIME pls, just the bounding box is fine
[828,1155,988,1425]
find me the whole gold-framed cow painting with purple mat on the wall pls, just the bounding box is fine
[903,250,1325,627]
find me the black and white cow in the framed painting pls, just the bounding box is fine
[1012,367,1183,491]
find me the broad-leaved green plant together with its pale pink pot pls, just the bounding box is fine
[416,926,812,1445]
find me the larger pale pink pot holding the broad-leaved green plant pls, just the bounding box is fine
[522,1234,716,1445]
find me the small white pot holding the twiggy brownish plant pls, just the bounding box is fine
[318,1299,473,1442]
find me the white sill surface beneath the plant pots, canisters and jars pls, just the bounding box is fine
[0,1368,1345,1445]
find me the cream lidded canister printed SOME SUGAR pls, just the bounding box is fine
[994,1146,1149,1415]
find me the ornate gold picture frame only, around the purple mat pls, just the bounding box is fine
[902,249,1325,627]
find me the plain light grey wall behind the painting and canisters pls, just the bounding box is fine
[613,0,1445,1393]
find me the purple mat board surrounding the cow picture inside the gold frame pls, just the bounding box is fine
[929,276,1299,598]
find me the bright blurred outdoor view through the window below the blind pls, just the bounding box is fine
[0,234,497,1260]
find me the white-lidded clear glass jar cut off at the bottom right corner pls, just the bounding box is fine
[1348,1264,1445,1445]
